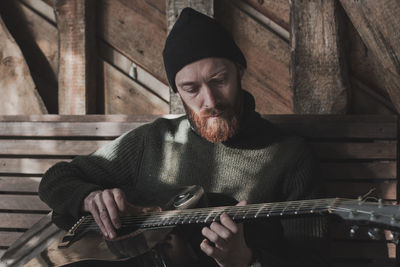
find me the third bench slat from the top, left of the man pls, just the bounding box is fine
[0,158,67,175]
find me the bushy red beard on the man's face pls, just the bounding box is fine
[183,98,242,143]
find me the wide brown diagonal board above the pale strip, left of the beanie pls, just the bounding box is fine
[101,0,168,84]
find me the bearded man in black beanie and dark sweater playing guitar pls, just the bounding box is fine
[39,8,326,267]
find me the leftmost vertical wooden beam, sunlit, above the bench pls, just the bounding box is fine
[54,0,97,115]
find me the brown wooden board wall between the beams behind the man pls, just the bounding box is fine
[0,0,397,114]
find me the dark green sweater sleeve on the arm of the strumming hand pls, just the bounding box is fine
[39,123,147,219]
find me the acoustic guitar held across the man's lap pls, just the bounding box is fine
[22,186,400,266]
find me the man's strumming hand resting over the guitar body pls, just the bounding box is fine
[82,188,161,239]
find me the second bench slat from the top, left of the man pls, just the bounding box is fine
[0,139,109,156]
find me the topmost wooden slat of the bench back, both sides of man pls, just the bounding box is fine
[0,115,397,140]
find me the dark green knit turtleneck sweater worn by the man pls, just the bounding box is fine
[39,93,328,262]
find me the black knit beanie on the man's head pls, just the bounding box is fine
[163,7,246,92]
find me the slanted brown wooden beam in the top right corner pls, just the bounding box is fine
[340,0,400,112]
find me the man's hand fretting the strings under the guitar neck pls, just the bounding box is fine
[200,201,252,267]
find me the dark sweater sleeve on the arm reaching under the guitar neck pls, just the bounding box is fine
[253,141,329,267]
